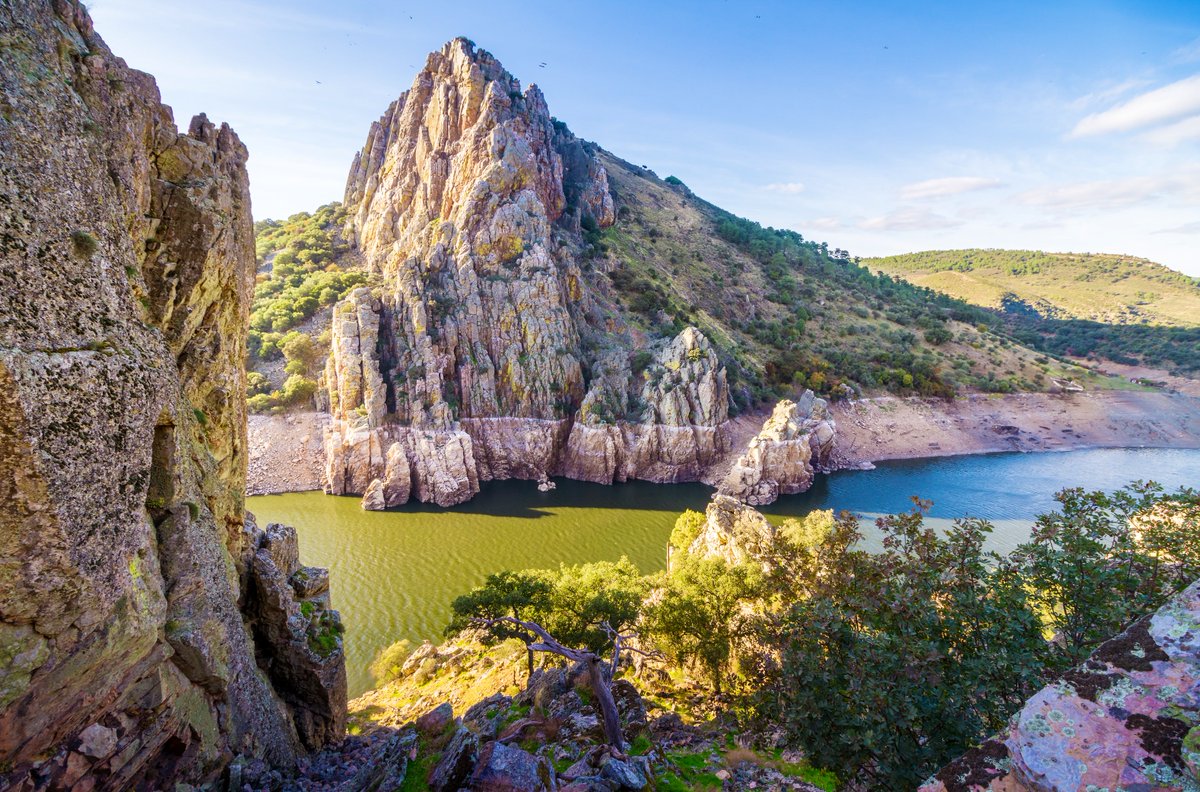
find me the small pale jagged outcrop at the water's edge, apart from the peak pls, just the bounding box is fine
[718,390,836,505]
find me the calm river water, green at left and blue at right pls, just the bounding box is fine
[247,449,1200,696]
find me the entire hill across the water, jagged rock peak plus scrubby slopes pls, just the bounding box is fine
[248,38,1120,509]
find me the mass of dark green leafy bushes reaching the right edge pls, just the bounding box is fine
[757,484,1200,788]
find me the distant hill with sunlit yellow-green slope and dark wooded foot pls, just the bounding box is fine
[864,250,1200,373]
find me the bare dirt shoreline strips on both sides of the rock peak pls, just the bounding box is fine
[246,390,1200,496]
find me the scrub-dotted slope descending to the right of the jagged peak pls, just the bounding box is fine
[595,152,1109,398]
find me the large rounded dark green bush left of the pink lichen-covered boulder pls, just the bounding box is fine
[760,502,1044,788]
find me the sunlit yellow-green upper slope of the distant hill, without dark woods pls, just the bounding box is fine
[863,248,1200,326]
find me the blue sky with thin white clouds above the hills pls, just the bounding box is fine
[90,0,1200,275]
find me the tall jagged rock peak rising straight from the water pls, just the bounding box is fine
[324,40,730,509]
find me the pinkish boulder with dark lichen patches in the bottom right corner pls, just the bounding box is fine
[922,581,1200,792]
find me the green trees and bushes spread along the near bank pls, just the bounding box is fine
[449,484,1200,788]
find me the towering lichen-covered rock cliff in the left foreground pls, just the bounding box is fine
[0,0,344,790]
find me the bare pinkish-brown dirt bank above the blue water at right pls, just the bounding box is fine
[833,391,1200,467]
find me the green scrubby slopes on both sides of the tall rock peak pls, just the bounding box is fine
[250,84,1106,414]
